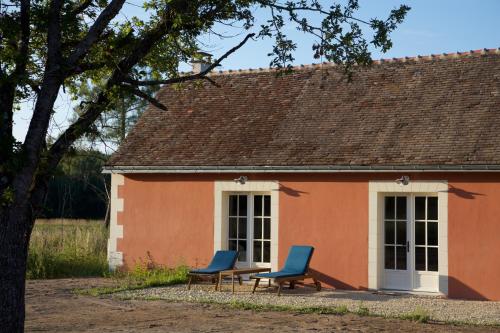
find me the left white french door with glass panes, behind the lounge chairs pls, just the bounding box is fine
[228,193,271,267]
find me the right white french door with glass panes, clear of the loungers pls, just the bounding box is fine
[383,194,439,292]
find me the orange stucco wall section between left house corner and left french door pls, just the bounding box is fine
[117,175,214,267]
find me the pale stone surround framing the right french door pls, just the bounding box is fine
[368,180,448,295]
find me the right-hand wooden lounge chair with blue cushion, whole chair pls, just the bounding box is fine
[251,245,321,296]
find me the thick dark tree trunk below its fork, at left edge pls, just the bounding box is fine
[0,201,32,333]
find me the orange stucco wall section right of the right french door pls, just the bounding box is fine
[448,174,500,300]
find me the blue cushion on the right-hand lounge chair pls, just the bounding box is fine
[255,245,314,279]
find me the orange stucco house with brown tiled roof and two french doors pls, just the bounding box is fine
[105,49,500,300]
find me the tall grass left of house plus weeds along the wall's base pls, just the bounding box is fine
[26,219,188,286]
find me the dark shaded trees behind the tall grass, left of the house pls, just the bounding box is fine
[40,149,110,219]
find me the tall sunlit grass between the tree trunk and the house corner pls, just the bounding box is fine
[26,221,108,279]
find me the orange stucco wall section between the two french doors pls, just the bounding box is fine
[278,175,368,289]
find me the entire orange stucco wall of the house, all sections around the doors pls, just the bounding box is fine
[114,173,500,300]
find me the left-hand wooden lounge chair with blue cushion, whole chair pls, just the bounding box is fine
[188,251,238,290]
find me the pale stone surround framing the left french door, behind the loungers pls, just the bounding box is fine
[214,181,279,270]
